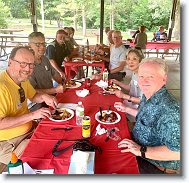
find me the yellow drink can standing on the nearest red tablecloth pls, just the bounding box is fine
[82,116,91,138]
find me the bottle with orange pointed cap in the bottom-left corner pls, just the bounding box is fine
[8,152,24,174]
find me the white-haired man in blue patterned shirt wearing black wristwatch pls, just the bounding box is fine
[115,58,180,174]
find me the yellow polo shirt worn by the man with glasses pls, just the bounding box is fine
[0,71,36,141]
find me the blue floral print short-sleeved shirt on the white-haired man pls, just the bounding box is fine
[132,86,180,170]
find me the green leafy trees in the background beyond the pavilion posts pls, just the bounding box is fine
[0,0,172,31]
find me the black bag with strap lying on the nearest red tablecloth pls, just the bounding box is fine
[52,139,102,156]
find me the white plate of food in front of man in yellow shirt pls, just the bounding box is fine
[49,108,74,122]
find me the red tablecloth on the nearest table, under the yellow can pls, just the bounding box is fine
[21,81,139,174]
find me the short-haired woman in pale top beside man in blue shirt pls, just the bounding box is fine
[111,48,144,122]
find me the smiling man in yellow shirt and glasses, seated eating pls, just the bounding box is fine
[0,46,57,173]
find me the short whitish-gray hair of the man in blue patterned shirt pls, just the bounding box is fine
[139,57,168,74]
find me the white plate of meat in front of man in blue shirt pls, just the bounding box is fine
[95,110,121,124]
